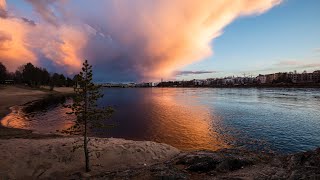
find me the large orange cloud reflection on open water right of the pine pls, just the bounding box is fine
[144,89,228,150]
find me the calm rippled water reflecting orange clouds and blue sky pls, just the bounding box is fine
[2,88,320,153]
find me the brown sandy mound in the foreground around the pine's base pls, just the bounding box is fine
[0,137,179,179]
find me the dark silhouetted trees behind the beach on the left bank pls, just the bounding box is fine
[0,62,75,88]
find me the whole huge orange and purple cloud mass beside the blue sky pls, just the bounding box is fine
[0,0,281,81]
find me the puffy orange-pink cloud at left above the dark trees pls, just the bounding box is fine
[0,0,87,73]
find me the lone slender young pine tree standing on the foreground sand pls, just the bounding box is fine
[63,60,114,172]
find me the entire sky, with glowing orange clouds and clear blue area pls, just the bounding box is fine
[0,0,320,82]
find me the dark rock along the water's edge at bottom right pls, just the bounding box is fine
[83,148,320,180]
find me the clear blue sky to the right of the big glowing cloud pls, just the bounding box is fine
[179,0,320,79]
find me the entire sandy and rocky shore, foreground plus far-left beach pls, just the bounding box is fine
[0,86,320,180]
